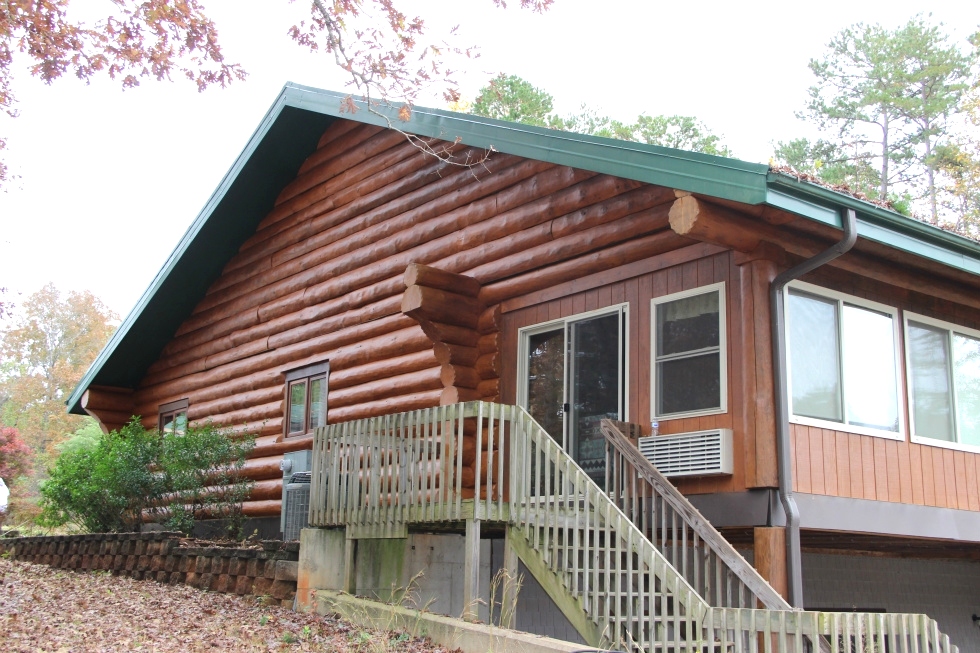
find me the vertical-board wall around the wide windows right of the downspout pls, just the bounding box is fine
[790,269,980,511]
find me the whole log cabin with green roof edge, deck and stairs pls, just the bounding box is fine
[68,84,980,651]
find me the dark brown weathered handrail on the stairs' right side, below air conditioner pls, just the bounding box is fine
[600,419,793,610]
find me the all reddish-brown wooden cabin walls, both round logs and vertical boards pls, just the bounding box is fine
[111,120,980,515]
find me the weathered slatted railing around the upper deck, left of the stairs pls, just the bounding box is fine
[310,402,510,532]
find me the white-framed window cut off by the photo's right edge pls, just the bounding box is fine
[905,313,980,451]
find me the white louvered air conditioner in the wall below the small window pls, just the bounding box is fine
[638,429,732,476]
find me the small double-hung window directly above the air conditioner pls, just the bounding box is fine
[651,283,728,419]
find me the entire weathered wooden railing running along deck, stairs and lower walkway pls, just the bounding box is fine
[310,402,958,653]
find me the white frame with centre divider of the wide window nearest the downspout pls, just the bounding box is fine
[777,281,908,442]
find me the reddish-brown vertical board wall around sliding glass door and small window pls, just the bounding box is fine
[500,250,755,494]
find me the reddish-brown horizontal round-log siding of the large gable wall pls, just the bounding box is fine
[134,121,690,514]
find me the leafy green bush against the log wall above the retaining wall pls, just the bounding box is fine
[39,417,252,533]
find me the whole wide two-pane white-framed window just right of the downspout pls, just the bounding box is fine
[786,283,902,439]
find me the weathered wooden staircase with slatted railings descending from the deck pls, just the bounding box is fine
[510,404,772,651]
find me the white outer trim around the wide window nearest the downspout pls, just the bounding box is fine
[783,281,907,442]
